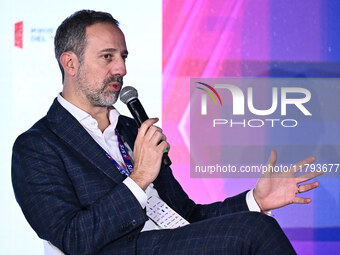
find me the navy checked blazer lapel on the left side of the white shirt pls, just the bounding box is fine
[47,99,125,183]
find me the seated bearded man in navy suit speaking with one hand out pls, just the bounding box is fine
[12,10,320,255]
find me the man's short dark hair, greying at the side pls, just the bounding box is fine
[54,10,119,82]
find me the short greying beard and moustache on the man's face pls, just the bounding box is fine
[77,67,123,107]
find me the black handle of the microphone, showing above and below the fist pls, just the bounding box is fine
[127,98,172,167]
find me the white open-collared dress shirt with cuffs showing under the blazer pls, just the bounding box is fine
[58,94,260,231]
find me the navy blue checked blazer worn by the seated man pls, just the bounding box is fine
[12,99,248,255]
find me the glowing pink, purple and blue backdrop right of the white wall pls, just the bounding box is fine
[162,0,340,254]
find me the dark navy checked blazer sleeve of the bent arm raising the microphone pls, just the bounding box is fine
[12,132,148,254]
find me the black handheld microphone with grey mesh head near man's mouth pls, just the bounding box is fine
[120,86,172,167]
